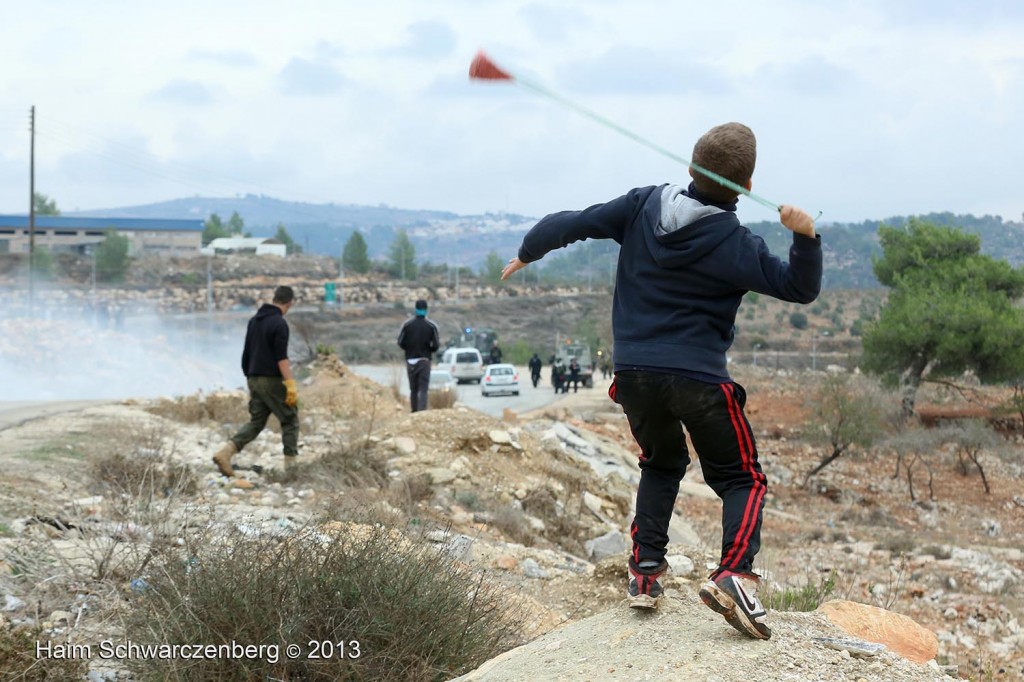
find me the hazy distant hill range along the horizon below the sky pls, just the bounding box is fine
[69,195,1024,289]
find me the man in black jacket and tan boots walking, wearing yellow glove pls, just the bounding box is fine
[213,287,299,476]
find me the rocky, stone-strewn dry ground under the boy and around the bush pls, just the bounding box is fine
[0,358,1024,680]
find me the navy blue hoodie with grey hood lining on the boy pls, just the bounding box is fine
[519,183,821,381]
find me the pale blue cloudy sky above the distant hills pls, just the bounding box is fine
[0,0,1024,221]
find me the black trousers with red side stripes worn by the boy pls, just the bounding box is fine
[608,371,768,571]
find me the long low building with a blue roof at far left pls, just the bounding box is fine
[0,215,204,256]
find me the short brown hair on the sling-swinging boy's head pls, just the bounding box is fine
[691,123,758,204]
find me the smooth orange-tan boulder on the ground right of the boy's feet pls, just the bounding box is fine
[818,599,939,664]
